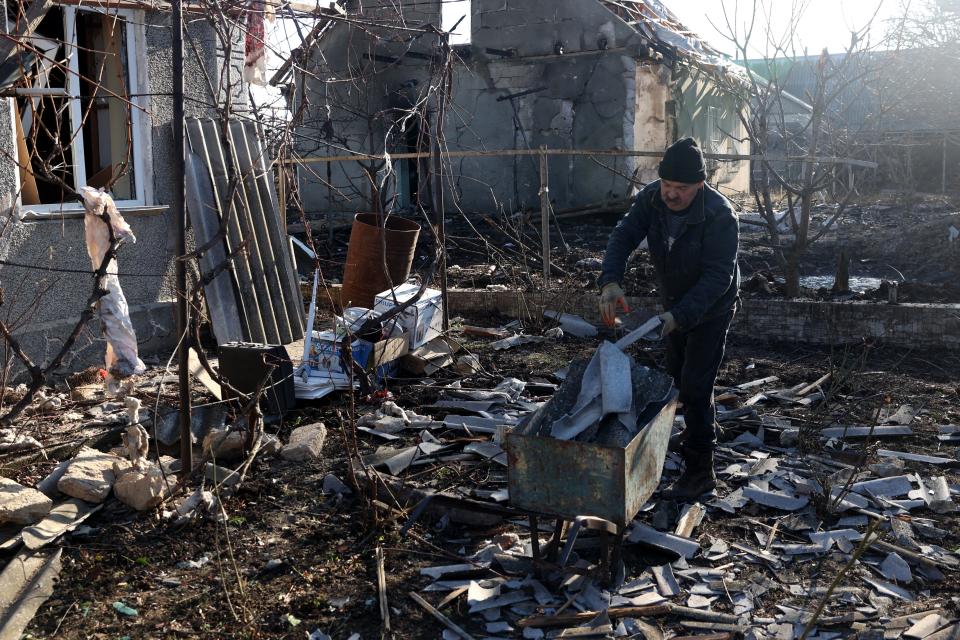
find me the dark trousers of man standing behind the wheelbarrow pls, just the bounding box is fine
[667,311,733,454]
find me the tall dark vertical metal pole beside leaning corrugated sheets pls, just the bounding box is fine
[170,0,193,477]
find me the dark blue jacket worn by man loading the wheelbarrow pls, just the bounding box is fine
[597,180,740,329]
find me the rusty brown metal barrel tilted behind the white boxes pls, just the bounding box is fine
[340,213,420,309]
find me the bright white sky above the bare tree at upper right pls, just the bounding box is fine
[664,0,904,57]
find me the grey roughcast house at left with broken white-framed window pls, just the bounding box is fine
[0,2,246,367]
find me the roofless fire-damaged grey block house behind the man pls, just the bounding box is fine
[288,0,749,215]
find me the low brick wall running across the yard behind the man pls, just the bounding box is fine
[438,289,960,350]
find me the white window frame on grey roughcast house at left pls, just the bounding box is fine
[9,4,153,219]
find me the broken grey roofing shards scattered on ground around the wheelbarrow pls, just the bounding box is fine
[328,348,960,640]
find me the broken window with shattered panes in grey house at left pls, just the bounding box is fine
[16,7,144,211]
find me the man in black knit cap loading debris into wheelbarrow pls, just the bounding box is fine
[598,138,740,500]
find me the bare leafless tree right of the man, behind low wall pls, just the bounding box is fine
[720,0,888,297]
